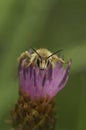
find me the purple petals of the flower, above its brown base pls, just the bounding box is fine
[19,56,71,100]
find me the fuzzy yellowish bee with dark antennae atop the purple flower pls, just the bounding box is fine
[18,48,68,70]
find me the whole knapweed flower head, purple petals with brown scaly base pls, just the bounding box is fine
[12,48,71,130]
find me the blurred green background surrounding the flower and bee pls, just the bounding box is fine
[0,0,86,130]
